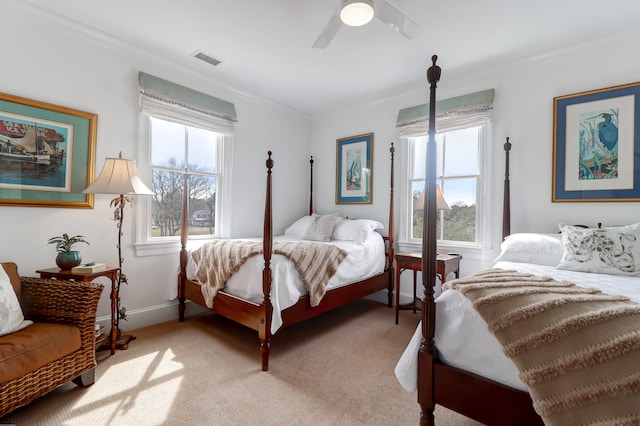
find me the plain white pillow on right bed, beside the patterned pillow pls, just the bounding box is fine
[496,233,563,266]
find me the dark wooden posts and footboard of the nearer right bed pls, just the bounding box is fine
[418,55,542,426]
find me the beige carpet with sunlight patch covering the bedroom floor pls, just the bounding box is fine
[0,300,478,426]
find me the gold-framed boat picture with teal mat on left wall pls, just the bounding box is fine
[0,93,98,208]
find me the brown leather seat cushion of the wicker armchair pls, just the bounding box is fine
[0,323,81,384]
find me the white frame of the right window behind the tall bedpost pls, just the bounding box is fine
[398,123,492,256]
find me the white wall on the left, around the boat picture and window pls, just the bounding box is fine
[0,2,311,329]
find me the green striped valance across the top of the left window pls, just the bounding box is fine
[138,71,238,123]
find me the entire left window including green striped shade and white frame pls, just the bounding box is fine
[136,72,237,255]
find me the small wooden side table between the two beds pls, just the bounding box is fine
[395,251,462,324]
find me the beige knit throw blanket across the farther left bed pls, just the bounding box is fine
[191,240,347,308]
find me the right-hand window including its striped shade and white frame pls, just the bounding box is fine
[396,89,494,248]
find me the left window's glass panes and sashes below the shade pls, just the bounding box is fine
[149,117,224,239]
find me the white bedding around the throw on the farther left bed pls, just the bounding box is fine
[187,232,385,333]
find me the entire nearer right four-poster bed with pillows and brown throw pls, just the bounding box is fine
[410,56,640,425]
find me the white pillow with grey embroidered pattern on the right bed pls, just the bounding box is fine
[558,223,640,276]
